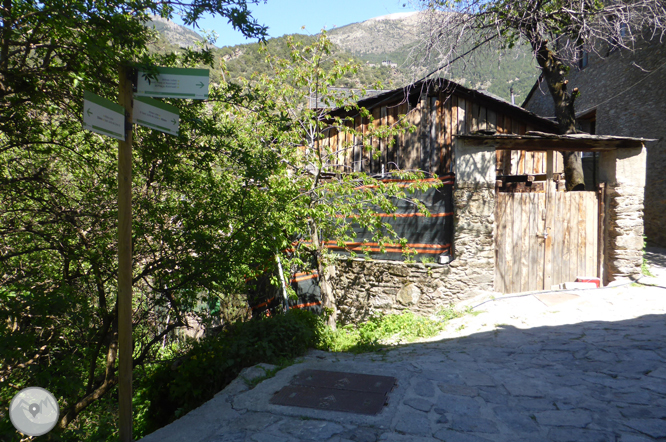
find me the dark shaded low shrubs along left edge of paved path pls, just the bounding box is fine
[137,309,323,435]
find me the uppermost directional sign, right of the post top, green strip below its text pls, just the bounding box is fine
[135,68,209,100]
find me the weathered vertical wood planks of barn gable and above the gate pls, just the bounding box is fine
[323,92,548,175]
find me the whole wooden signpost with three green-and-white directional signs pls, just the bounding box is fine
[83,66,209,442]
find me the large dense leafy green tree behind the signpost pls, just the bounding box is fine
[0,0,277,439]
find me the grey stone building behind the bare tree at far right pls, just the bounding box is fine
[523,39,666,247]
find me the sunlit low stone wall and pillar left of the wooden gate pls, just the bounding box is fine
[330,185,495,323]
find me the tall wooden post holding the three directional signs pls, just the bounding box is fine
[118,66,133,442]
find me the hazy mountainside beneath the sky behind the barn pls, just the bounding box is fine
[148,12,539,102]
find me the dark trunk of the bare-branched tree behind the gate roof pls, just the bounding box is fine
[531,38,585,191]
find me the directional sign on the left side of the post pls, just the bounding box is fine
[83,91,125,141]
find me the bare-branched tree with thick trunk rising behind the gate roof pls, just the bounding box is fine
[421,0,666,190]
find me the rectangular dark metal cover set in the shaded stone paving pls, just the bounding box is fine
[270,370,396,415]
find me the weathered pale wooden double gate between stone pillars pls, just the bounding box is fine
[495,192,599,293]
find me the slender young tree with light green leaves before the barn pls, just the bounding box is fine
[243,32,432,327]
